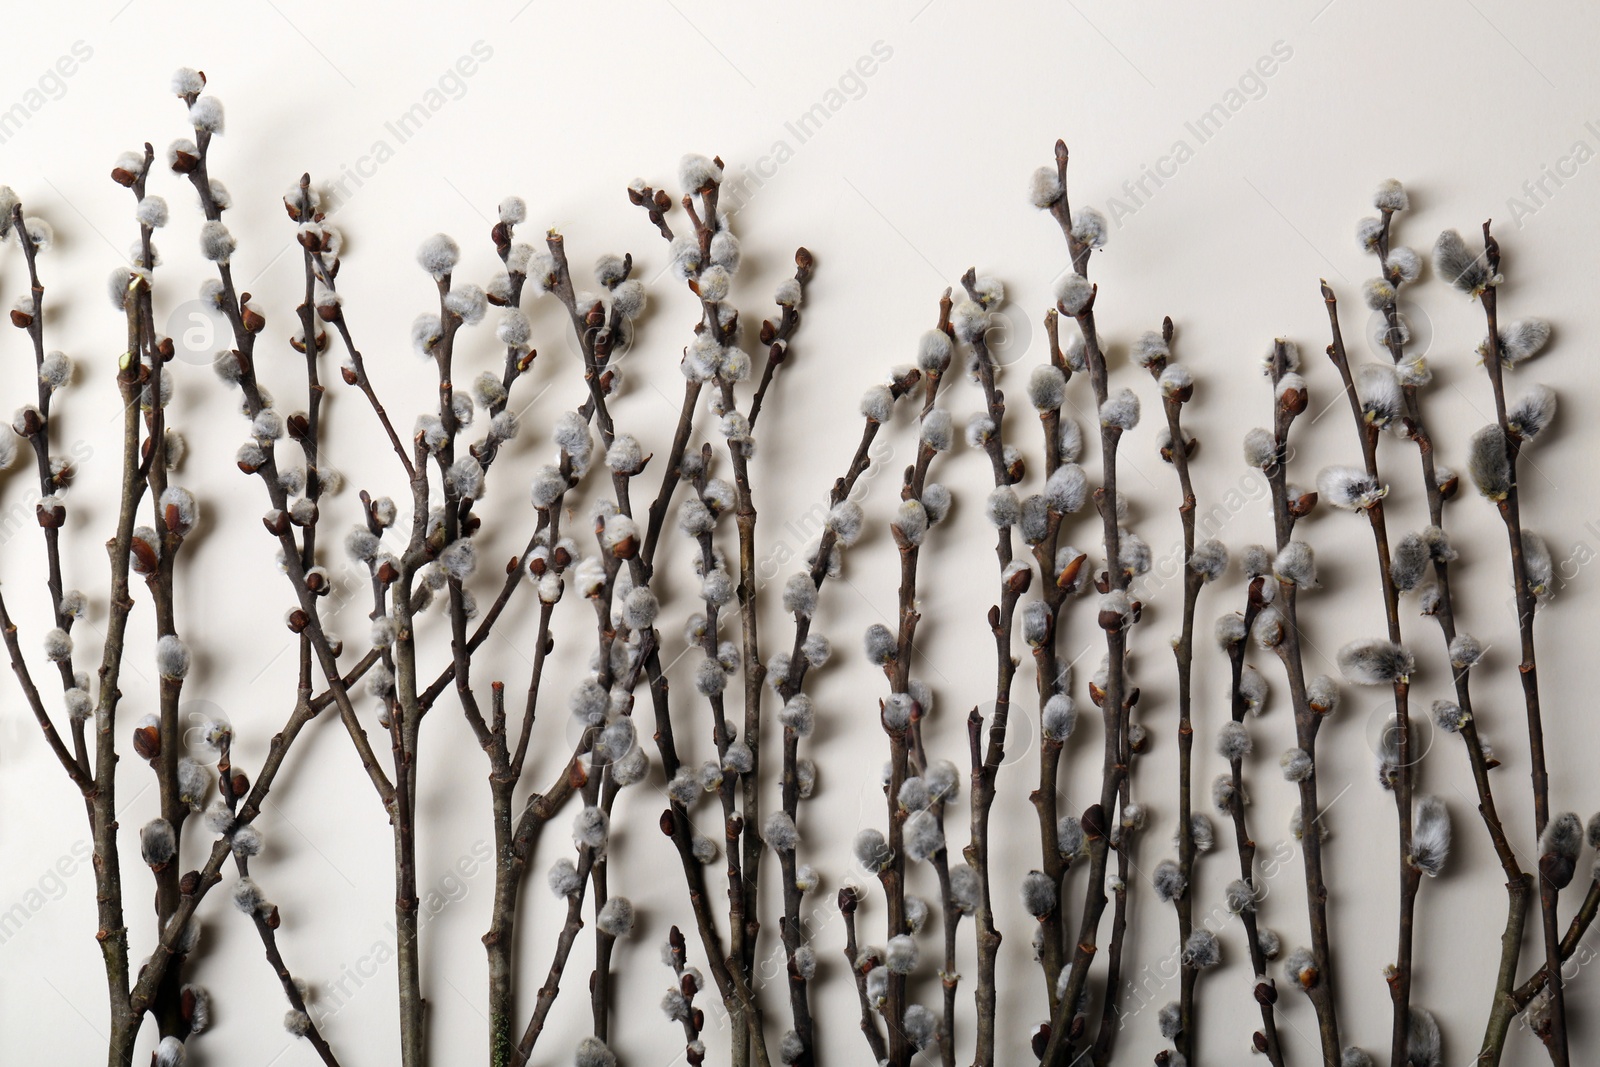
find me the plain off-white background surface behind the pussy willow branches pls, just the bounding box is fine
[0,0,1600,1067]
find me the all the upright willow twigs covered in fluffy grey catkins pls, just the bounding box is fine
[0,70,1600,1067]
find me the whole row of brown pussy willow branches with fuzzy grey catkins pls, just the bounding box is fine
[0,69,1600,1067]
